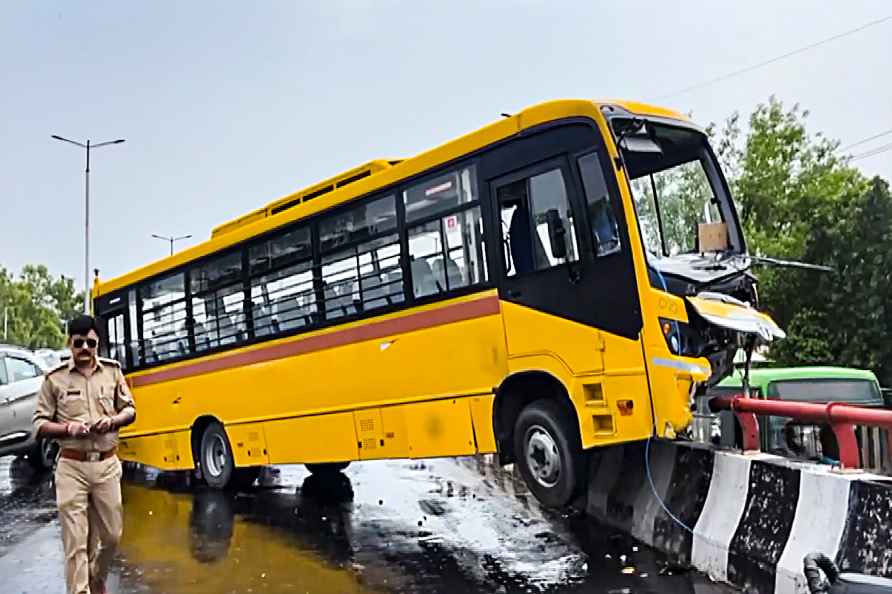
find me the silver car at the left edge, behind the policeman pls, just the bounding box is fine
[0,346,57,469]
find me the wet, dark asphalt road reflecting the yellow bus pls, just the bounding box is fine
[0,450,733,594]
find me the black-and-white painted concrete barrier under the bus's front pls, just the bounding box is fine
[586,440,892,594]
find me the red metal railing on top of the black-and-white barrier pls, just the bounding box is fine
[709,396,892,474]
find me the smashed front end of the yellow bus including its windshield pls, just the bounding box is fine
[603,105,784,437]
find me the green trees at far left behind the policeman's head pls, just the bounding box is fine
[0,265,83,349]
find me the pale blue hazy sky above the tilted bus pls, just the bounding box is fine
[0,0,892,286]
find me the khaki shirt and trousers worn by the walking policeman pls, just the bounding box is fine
[34,358,133,594]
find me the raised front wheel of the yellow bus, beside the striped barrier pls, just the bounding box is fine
[514,399,584,507]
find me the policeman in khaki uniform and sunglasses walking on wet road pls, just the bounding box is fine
[34,316,136,594]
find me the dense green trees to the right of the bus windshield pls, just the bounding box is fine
[710,97,892,384]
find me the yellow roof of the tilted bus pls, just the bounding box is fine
[93,99,689,297]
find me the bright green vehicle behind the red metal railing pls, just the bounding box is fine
[697,360,884,455]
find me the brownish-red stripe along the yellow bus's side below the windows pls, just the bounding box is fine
[130,296,499,387]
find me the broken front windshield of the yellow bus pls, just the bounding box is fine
[623,123,736,257]
